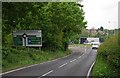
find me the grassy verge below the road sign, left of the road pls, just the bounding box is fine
[2,48,71,72]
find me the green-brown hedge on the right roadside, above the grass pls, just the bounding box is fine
[98,33,120,67]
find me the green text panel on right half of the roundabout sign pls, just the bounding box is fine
[28,35,42,45]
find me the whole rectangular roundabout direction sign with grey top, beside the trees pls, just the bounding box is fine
[13,30,42,47]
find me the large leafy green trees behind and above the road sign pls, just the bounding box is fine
[2,2,87,50]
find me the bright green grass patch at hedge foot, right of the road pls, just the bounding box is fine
[92,57,118,78]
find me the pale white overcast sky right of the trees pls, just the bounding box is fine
[81,0,120,29]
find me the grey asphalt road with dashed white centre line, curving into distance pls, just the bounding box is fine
[2,46,96,78]
